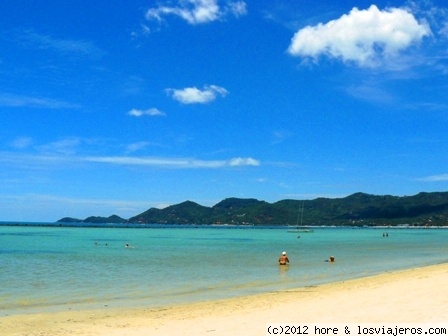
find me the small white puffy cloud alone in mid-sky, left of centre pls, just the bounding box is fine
[166,85,228,104]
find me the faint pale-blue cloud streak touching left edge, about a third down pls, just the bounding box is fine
[0,93,80,109]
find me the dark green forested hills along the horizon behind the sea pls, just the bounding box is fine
[58,192,448,226]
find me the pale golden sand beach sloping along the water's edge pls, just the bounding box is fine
[0,264,448,336]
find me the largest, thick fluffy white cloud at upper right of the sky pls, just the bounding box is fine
[288,5,431,67]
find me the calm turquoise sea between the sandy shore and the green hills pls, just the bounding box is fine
[0,225,448,316]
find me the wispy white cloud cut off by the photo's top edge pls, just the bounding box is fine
[146,0,247,25]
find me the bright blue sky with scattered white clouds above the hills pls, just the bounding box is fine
[0,0,448,221]
